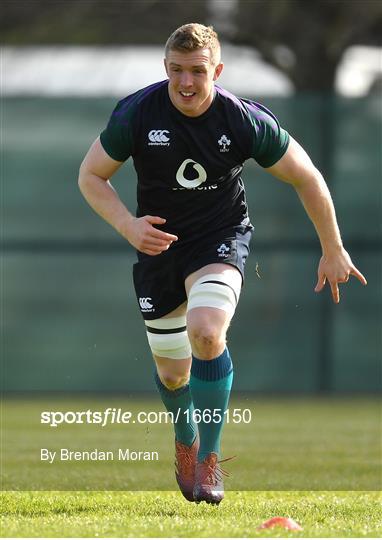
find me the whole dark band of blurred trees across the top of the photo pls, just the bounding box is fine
[0,0,382,91]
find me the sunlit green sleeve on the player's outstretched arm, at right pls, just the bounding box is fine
[247,102,290,167]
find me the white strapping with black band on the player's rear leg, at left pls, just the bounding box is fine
[145,315,191,360]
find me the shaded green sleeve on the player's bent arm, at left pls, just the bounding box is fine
[100,97,136,161]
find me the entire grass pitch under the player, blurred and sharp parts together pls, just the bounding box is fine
[1,396,382,537]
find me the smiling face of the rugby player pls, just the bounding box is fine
[164,49,223,116]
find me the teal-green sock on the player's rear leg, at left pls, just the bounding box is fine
[155,372,198,446]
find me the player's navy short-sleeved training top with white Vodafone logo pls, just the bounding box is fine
[100,80,289,247]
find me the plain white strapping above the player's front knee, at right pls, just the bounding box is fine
[187,272,242,315]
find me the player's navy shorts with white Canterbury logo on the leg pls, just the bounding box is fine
[133,225,252,320]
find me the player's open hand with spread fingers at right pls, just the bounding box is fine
[314,248,367,304]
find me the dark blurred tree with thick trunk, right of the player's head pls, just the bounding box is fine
[231,0,382,92]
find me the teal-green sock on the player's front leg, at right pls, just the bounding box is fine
[190,348,233,461]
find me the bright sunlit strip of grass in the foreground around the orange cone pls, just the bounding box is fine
[1,492,382,538]
